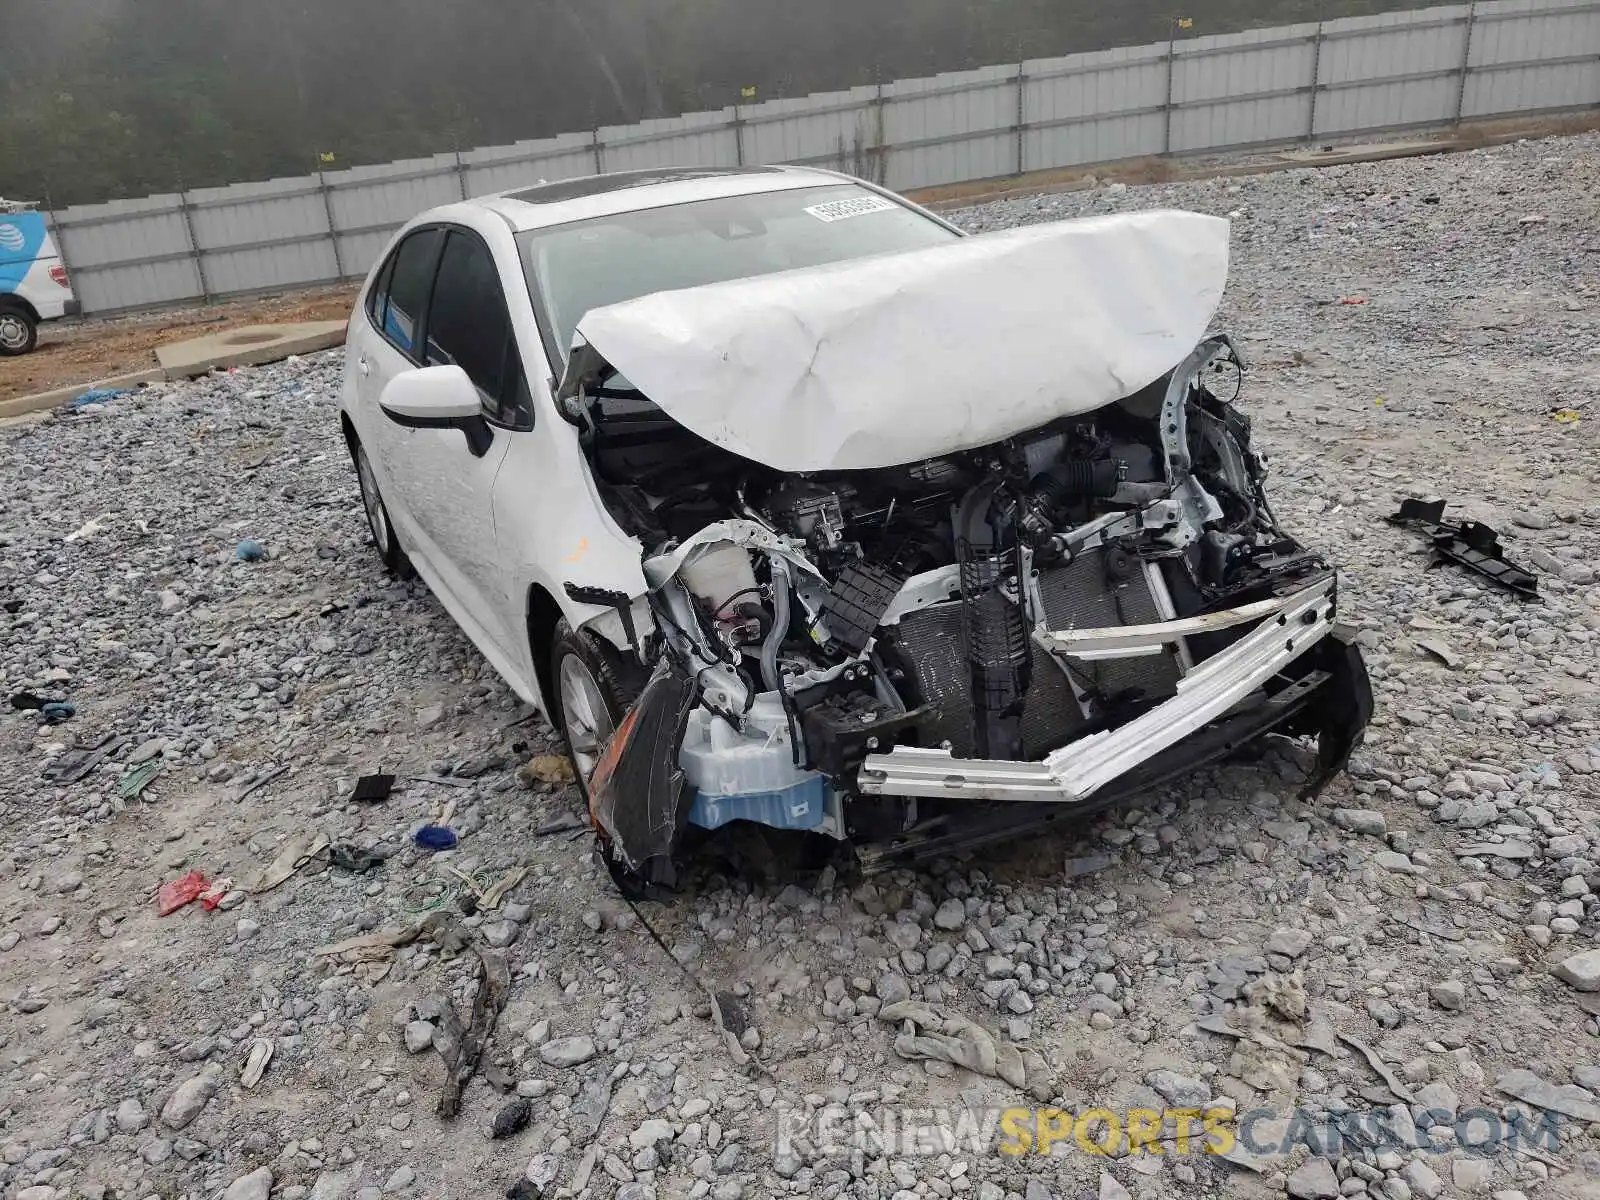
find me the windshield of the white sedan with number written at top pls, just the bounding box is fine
[517,184,960,363]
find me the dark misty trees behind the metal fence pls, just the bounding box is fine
[0,0,1406,206]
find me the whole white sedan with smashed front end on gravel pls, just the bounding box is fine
[342,168,1373,886]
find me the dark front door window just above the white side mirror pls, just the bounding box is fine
[426,229,533,427]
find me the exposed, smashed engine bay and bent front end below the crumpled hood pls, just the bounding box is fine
[573,338,1371,880]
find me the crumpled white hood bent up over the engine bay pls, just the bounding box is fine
[578,211,1229,472]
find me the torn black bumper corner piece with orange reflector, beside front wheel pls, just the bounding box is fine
[589,658,698,886]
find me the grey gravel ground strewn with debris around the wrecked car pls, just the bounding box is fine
[0,134,1600,1200]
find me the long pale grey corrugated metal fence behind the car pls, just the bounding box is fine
[51,0,1600,312]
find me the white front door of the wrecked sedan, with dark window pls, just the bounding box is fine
[358,226,530,669]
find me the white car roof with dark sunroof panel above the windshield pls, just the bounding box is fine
[467,166,856,232]
